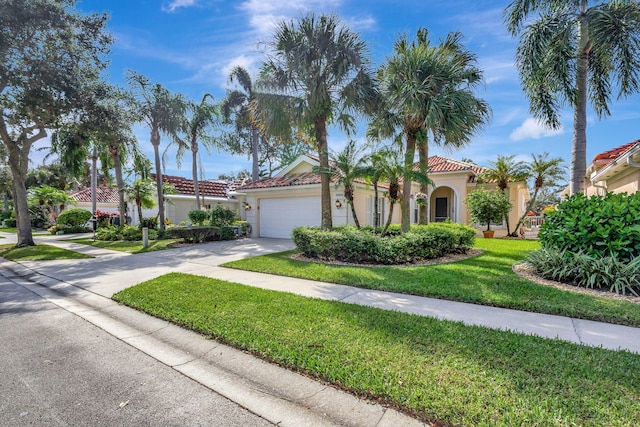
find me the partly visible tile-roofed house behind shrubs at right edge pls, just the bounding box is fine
[585,139,640,196]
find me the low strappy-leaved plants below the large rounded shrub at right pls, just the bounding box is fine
[526,248,640,296]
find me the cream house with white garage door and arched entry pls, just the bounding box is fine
[237,155,529,238]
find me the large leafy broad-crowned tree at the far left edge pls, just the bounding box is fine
[0,0,111,247]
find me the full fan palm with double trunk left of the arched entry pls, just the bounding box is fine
[372,28,491,232]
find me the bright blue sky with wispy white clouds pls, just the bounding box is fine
[70,0,640,179]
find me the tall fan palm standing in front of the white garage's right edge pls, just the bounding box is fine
[256,14,371,230]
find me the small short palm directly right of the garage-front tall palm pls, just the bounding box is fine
[329,140,367,228]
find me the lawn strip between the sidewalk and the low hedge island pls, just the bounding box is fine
[224,239,640,326]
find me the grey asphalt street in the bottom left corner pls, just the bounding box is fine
[0,276,273,426]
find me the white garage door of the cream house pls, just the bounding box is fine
[260,197,322,239]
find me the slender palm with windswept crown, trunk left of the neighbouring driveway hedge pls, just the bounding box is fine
[127,71,186,230]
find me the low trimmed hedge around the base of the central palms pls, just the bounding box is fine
[293,224,476,265]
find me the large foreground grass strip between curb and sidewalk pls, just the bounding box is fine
[114,274,640,427]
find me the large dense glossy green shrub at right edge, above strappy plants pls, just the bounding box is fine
[538,193,640,262]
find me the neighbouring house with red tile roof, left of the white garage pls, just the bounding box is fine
[151,174,244,224]
